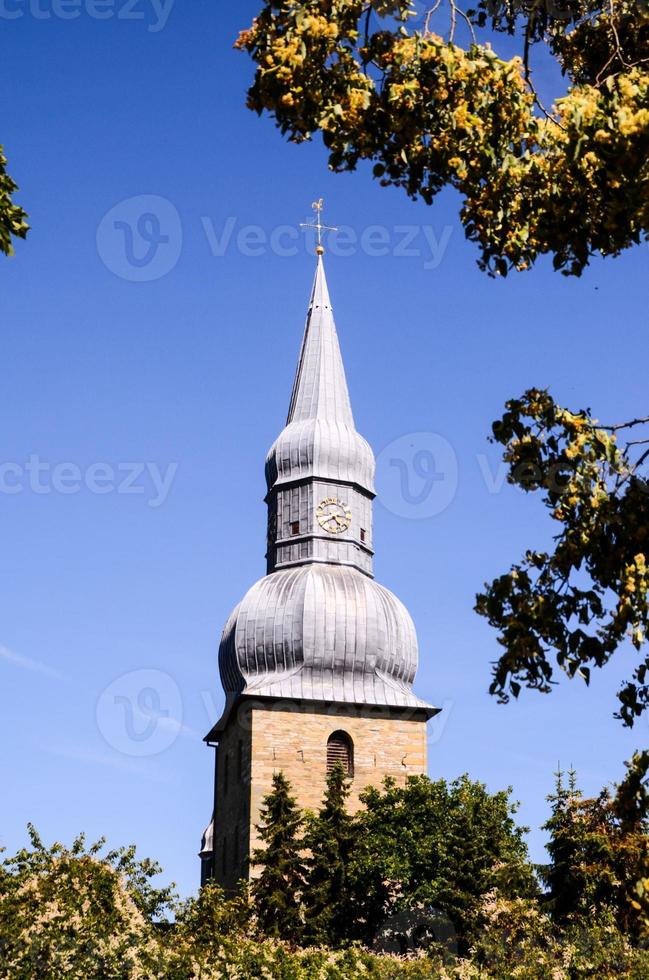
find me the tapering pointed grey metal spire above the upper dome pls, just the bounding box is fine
[288,254,354,428]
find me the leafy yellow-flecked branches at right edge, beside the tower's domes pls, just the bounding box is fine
[476,389,649,726]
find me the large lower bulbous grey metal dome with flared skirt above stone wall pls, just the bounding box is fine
[219,563,428,709]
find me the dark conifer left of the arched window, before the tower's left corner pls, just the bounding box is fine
[251,772,304,941]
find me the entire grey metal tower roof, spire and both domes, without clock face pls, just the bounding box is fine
[208,257,437,738]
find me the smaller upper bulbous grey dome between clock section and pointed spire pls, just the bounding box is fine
[266,418,375,493]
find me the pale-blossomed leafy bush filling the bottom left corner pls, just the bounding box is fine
[0,826,173,980]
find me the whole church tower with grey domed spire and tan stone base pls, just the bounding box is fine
[200,230,437,889]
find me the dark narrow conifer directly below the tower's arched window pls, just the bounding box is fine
[304,763,358,946]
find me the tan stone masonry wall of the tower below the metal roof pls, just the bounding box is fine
[210,701,426,888]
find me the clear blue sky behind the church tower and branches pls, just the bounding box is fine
[0,0,649,893]
